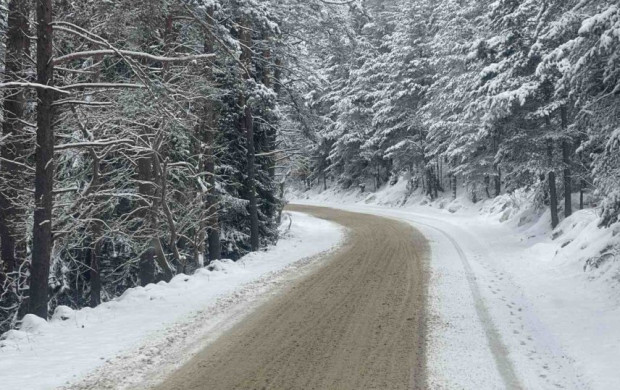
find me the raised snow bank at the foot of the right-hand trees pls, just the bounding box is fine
[288,177,620,288]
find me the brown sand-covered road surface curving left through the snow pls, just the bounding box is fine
[156,205,430,390]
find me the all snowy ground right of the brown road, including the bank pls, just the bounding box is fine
[290,182,620,390]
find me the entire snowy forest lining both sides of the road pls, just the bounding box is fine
[0,0,620,330]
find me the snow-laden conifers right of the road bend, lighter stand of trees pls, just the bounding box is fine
[288,0,620,227]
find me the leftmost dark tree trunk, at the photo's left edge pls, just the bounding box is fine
[0,0,29,284]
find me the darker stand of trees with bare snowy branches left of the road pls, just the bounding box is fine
[0,0,302,329]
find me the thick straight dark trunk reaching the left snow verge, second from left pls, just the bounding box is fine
[29,0,54,318]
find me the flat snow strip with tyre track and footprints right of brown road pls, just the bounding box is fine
[295,201,620,389]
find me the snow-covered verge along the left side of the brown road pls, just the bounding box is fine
[0,213,344,390]
